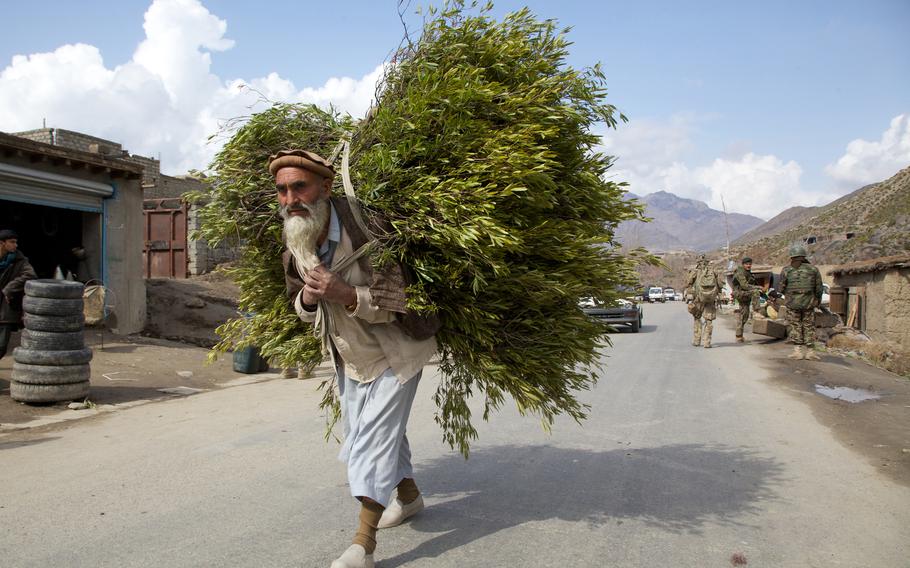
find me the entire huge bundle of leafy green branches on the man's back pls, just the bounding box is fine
[191,3,647,455]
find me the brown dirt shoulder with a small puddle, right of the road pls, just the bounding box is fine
[724,317,910,487]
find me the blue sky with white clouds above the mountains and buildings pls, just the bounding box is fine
[0,0,910,218]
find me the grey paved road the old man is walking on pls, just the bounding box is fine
[0,303,910,568]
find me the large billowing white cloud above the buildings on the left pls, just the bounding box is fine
[0,0,383,174]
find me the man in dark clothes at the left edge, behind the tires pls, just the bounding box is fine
[0,229,38,358]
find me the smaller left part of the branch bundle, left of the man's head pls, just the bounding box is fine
[188,104,352,380]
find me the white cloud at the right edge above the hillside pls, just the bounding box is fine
[825,114,910,189]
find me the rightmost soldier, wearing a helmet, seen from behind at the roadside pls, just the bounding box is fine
[780,245,822,360]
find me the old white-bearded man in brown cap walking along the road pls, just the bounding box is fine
[269,150,439,568]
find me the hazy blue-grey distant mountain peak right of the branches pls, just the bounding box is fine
[616,191,764,252]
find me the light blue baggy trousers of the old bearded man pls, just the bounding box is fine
[337,368,423,507]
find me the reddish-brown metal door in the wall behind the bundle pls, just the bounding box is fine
[142,198,189,278]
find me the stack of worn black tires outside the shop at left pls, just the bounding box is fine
[9,280,92,403]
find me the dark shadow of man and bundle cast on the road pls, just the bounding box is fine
[382,444,783,568]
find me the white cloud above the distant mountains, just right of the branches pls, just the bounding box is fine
[602,114,834,219]
